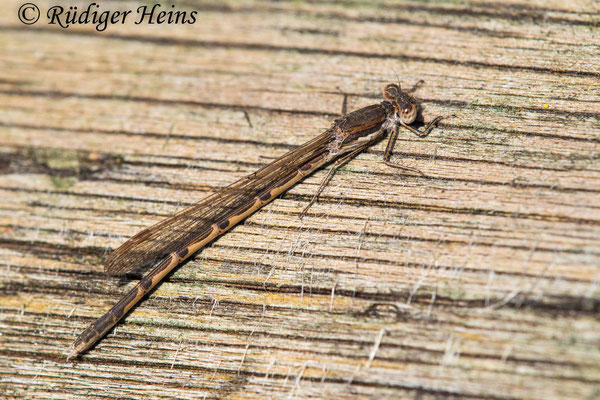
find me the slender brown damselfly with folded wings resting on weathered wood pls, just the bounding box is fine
[68,83,442,358]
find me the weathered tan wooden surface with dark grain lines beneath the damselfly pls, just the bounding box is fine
[0,0,600,399]
